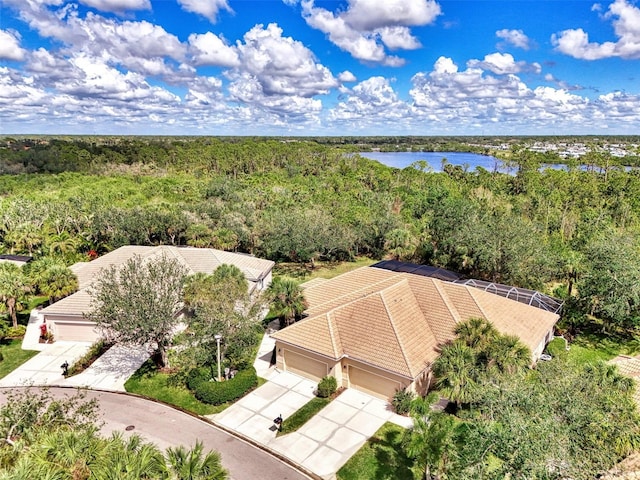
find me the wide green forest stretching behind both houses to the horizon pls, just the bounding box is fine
[0,137,640,335]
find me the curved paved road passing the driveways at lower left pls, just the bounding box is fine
[0,387,309,480]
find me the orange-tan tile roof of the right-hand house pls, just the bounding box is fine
[272,267,558,378]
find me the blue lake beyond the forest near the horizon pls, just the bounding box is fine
[360,152,508,172]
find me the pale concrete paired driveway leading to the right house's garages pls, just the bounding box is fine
[210,370,410,479]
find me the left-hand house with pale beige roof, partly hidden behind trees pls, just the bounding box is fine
[40,245,274,342]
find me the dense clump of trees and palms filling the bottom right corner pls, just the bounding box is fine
[406,320,640,480]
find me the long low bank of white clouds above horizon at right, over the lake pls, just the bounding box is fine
[402,57,640,134]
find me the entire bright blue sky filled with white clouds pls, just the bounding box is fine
[0,0,640,135]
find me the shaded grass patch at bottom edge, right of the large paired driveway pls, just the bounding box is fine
[337,422,413,480]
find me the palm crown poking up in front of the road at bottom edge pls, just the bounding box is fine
[166,442,229,480]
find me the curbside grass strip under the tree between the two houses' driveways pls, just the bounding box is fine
[124,360,221,415]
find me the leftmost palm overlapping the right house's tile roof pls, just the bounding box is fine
[432,341,478,407]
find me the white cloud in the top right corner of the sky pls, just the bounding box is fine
[551,0,640,60]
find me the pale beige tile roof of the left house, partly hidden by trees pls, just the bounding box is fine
[42,245,274,315]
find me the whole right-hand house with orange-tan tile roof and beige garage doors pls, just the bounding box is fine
[272,266,559,399]
